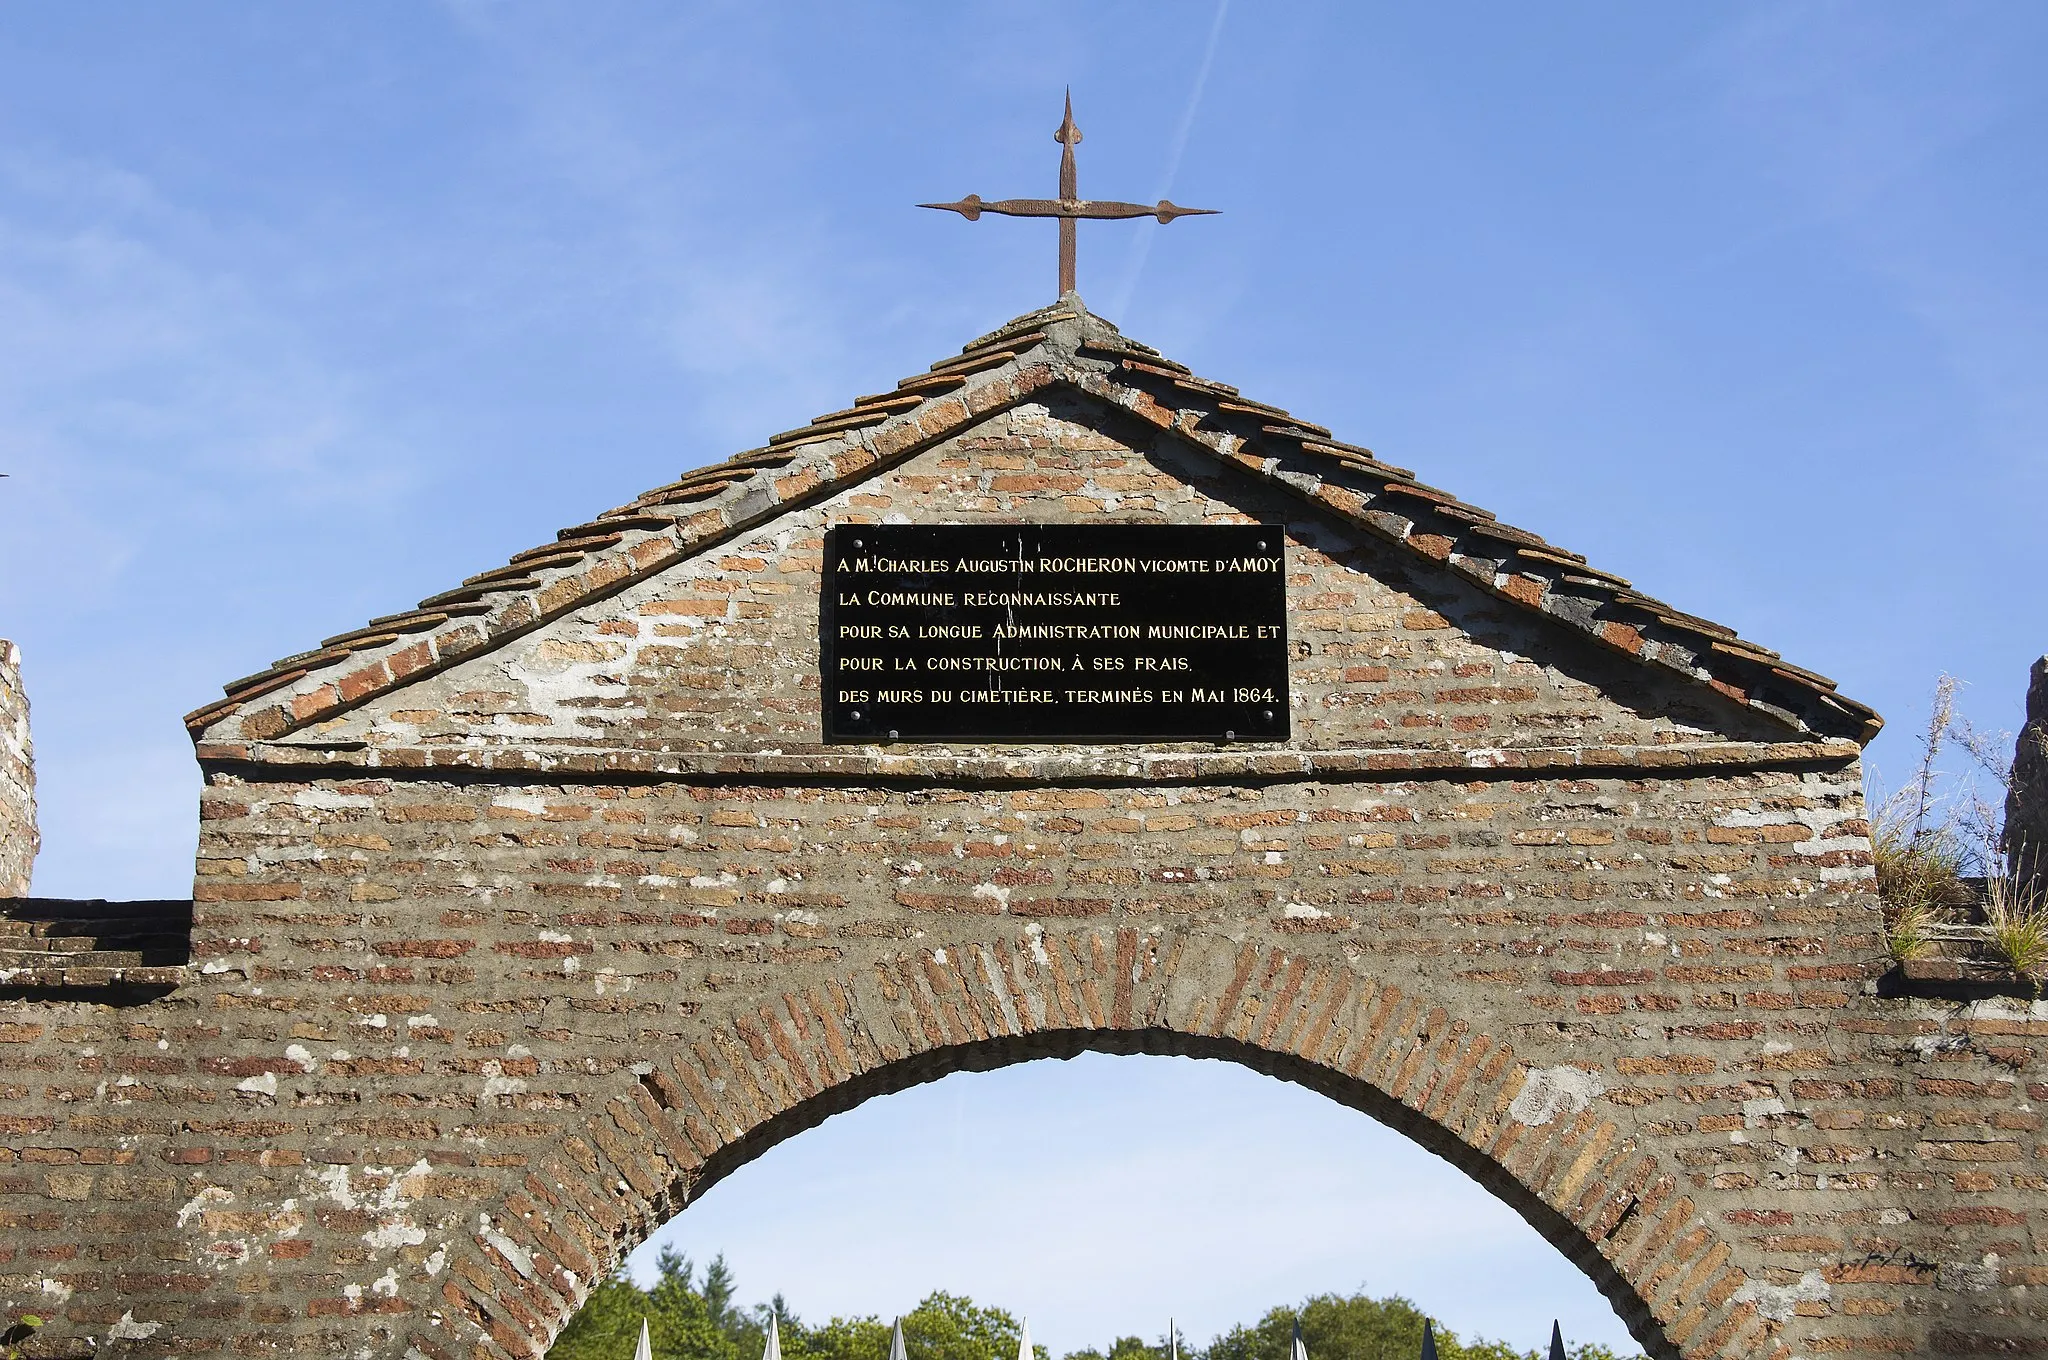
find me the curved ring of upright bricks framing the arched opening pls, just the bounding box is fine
[428,924,1761,1360]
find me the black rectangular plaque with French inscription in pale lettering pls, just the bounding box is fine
[819,524,1288,741]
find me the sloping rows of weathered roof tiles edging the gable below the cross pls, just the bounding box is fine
[186,297,1882,741]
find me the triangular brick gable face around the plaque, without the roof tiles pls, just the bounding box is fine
[268,389,1810,760]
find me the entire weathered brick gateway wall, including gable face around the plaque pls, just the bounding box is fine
[0,360,2048,1360]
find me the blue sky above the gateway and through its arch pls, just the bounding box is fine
[0,0,2048,1346]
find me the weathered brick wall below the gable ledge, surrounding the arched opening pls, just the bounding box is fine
[0,768,2048,1356]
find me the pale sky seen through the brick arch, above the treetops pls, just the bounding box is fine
[610,1053,1636,1360]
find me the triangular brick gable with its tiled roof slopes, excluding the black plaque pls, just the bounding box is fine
[188,301,1878,756]
